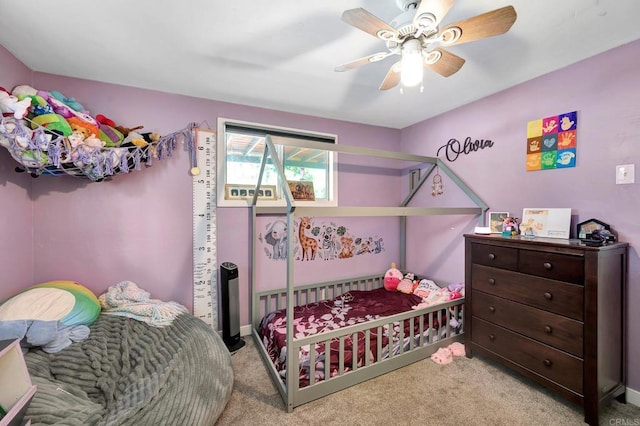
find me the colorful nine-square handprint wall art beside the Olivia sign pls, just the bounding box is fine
[526,111,578,171]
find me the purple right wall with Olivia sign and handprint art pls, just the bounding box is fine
[401,41,640,389]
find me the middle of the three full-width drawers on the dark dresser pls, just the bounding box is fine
[471,290,583,358]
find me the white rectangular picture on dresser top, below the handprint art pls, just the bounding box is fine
[520,208,571,238]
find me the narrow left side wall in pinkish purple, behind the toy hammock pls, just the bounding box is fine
[0,46,33,292]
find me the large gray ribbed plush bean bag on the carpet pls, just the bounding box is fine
[25,314,233,426]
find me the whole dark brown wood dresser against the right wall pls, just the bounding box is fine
[464,234,627,425]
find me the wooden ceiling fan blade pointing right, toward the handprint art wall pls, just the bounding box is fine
[440,6,518,46]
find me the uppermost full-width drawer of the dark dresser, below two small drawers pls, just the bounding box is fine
[471,264,584,321]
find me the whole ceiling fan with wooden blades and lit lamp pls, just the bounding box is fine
[335,0,517,90]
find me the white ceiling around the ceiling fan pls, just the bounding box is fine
[0,0,640,129]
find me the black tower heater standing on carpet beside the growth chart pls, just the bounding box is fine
[220,262,244,352]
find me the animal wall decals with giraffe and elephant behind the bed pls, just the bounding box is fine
[258,217,384,262]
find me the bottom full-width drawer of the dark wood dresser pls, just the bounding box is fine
[471,318,583,394]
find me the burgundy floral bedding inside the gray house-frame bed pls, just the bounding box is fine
[259,288,448,387]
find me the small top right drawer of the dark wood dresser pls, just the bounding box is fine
[518,250,584,284]
